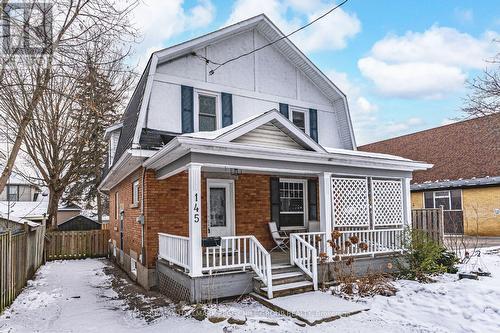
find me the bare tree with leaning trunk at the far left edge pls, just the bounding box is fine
[0,0,136,197]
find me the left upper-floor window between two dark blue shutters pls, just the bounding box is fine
[195,92,220,131]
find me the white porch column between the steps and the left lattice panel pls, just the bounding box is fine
[318,172,333,258]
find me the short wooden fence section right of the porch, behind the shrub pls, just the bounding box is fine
[411,207,444,244]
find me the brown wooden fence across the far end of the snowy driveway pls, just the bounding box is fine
[46,230,109,260]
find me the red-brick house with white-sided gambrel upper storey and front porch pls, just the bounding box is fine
[99,15,430,302]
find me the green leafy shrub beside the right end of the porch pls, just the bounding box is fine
[397,230,458,282]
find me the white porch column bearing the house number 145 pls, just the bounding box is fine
[187,163,202,276]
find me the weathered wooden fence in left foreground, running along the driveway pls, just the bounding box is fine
[0,226,45,312]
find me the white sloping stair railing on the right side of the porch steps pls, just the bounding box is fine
[290,233,318,290]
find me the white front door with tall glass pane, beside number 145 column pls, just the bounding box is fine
[207,179,234,237]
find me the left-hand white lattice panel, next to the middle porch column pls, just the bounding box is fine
[332,177,370,226]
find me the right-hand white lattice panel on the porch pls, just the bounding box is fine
[372,179,403,226]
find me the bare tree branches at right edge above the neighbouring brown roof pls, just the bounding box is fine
[463,41,500,117]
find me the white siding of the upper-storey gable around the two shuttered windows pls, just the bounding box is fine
[145,30,349,148]
